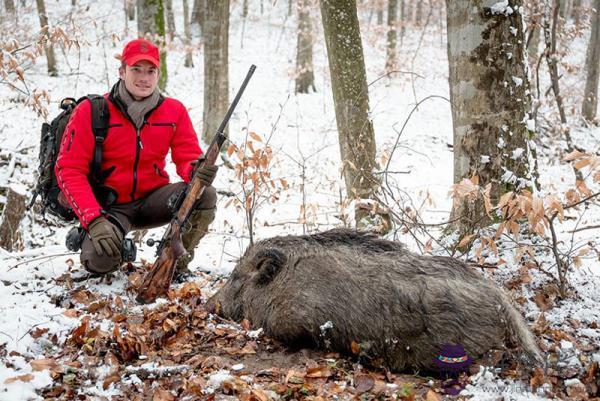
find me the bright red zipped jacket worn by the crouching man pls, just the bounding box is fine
[55,87,202,228]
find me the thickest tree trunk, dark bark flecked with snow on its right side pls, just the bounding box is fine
[446,0,533,233]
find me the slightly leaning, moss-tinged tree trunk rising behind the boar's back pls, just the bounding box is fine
[320,0,377,222]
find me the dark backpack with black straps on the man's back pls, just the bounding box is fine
[29,95,114,222]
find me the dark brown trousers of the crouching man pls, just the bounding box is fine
[80,182,217,274]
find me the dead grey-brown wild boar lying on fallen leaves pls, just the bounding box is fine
[207,229,544,371]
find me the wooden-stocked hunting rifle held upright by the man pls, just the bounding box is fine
[136,65,256,303]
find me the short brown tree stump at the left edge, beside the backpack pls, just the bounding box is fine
[0,187,27,251]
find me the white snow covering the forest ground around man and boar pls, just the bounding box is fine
[0,0,600,400]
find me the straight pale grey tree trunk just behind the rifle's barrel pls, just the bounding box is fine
[202,0,229,143]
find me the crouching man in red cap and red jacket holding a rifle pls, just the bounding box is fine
[55,39,217,275]
